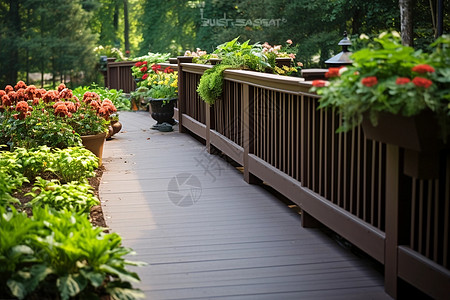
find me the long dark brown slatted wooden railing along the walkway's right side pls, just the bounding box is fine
[178,57,450,299]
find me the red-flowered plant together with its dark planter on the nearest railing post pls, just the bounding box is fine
[312,32,450,177]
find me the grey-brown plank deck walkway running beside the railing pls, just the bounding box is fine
[100,112,391,299]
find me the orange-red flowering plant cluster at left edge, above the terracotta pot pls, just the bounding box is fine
[0,81,117,148]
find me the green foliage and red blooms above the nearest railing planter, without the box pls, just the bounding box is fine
[312,32,450,137]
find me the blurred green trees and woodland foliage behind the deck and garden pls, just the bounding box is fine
[0,0,450,88]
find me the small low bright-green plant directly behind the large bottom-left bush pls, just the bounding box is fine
[27,177,100,213]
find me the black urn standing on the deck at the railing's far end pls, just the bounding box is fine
[149,98,178,131]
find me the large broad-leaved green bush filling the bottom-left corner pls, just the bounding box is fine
[0,207,143,300]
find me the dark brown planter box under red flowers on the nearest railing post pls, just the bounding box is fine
[362,111,445,179]
